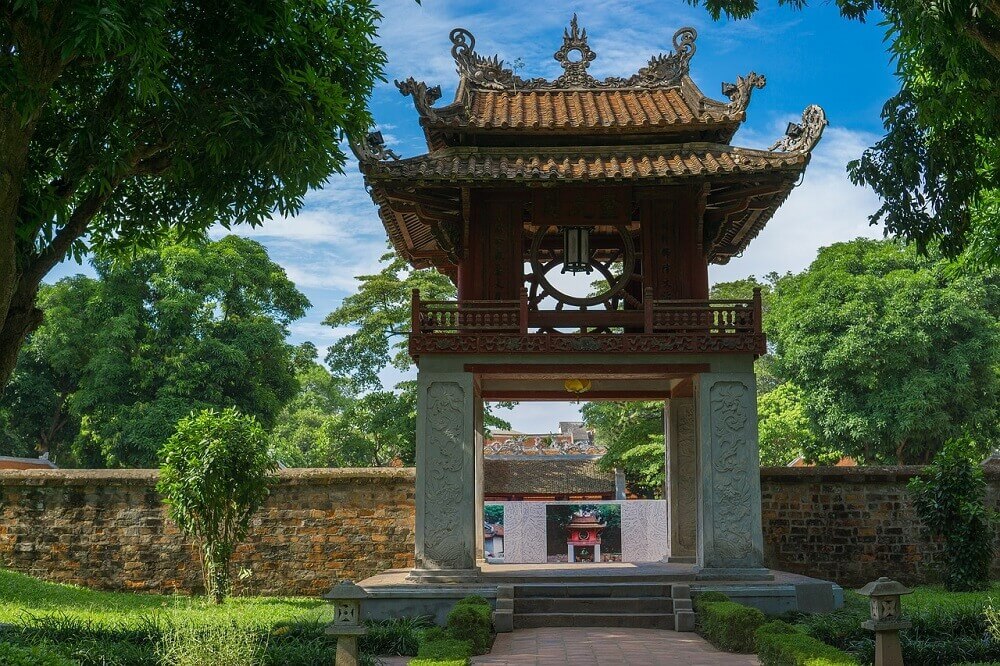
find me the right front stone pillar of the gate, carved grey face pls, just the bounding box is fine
[695,372,769,579]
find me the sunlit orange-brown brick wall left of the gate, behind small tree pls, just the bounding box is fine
[0,469,414,595]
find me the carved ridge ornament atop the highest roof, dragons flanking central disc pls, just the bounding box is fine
[452,14,698,94]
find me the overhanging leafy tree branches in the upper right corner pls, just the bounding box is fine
[689,0,1000,264]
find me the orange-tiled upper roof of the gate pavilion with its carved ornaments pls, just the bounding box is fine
[396,15,764,150]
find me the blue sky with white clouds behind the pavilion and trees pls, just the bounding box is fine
[49,0,896,432]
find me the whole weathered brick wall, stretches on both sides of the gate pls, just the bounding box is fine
[0,467,1000,595]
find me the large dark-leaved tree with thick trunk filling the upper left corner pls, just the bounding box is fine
[0,0,385,386]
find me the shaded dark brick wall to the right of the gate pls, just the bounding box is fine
[761,467,1000,586]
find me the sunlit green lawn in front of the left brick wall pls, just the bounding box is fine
[0,569,333,628]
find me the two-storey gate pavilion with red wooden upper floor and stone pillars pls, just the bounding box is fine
[351,16,826,582]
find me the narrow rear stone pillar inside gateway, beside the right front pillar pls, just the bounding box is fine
[663,398,698,564]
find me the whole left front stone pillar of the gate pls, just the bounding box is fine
[410,370,483,582]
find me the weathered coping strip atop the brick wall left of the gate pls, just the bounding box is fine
[0,467,415,486]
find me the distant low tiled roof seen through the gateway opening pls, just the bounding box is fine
[483,457,615,495]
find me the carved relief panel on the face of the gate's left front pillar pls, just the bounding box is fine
[424,382,472,569]
